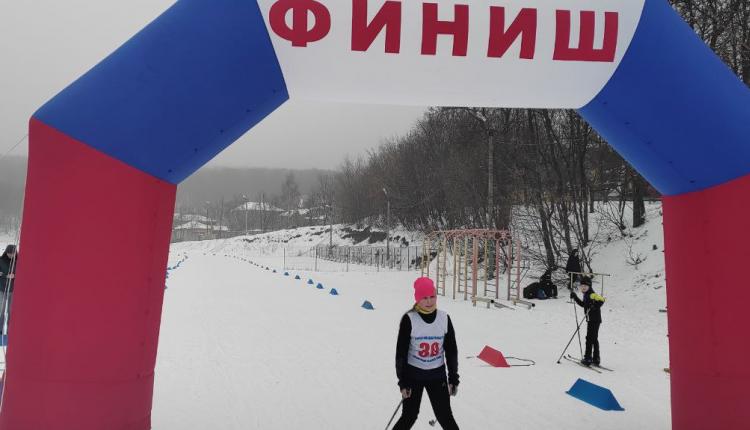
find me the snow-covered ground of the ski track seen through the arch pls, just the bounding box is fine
[153,204,670,430]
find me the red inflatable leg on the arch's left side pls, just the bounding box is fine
[0,120,176,430]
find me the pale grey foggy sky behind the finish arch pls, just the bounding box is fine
[0,0,424,169]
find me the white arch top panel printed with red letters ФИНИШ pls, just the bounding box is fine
[258,0,645,108]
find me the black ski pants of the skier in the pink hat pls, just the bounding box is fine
[393,379,458,430]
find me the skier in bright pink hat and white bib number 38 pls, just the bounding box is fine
[393,278,458,430]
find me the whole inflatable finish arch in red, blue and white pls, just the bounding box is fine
[0,0,750,430]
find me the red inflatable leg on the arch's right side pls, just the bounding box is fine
[664,177,750,430]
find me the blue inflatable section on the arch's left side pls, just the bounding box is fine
[34,0,289,184]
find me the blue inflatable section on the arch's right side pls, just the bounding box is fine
[579,0,750,195]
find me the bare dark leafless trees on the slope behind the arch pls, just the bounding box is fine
[310,0,750,269]
